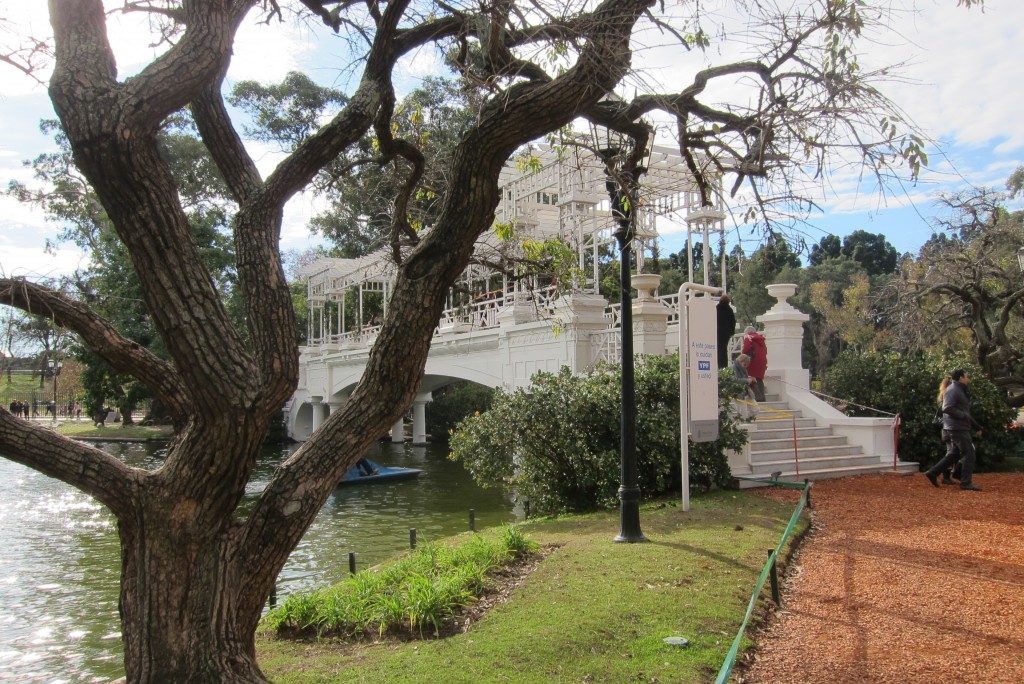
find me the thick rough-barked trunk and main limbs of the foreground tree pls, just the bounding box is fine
[0,0,646,684]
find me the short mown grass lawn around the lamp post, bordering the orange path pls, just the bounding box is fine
[253,491,806,684]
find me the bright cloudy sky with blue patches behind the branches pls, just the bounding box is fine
[0,0,1024,277]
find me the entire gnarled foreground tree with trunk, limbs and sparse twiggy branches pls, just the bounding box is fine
[0,0,974,684]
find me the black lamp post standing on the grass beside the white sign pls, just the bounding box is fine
[591,121,647,544]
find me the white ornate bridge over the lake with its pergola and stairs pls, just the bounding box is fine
[285,140,916,478]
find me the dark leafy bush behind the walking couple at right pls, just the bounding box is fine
[822,351,1016,469]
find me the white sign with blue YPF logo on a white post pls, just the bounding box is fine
[679,283,722,511]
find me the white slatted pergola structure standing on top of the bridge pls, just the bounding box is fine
[299,137,726,345]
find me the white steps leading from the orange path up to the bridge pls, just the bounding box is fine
[730,395,919,487]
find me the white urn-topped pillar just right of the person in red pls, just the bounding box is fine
[757,283,811,393]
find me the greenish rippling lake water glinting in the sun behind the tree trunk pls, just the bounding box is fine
[0,442,516,684]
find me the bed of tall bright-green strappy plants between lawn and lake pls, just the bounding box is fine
[263,526,537,638]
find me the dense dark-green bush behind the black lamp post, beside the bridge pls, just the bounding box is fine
[450,355,745,514]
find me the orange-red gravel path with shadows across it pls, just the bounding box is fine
[737,473,1024,684]
